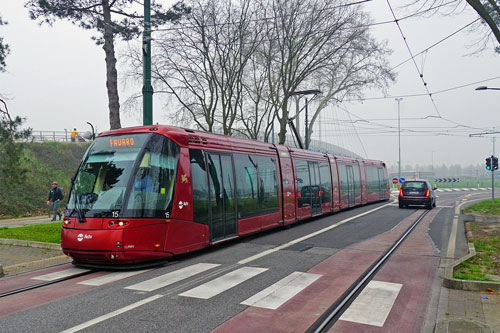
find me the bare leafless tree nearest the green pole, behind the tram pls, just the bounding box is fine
[153,0,259,135]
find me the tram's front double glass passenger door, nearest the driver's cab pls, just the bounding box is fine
[207,153,237,242]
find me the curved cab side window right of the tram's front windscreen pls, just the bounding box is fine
[127,135,179,217]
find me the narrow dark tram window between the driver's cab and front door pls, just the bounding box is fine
[189,149,209,224]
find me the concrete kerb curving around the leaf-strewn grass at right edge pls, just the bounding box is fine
[443,243,500,291]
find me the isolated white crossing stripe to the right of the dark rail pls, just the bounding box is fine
[340,281,403,327]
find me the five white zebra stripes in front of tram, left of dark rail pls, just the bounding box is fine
[31,263,322,310]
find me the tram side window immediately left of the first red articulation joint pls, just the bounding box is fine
[255,156,279,214]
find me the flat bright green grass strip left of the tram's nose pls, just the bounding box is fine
[0,222,62,244]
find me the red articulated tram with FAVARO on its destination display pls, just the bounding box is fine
[61,126,390,265]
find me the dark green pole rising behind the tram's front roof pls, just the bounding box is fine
[142,0,153,125]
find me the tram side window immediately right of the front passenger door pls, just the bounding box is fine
[233,154,259,218]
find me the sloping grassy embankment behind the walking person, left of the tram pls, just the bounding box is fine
[0,142,88,219]
